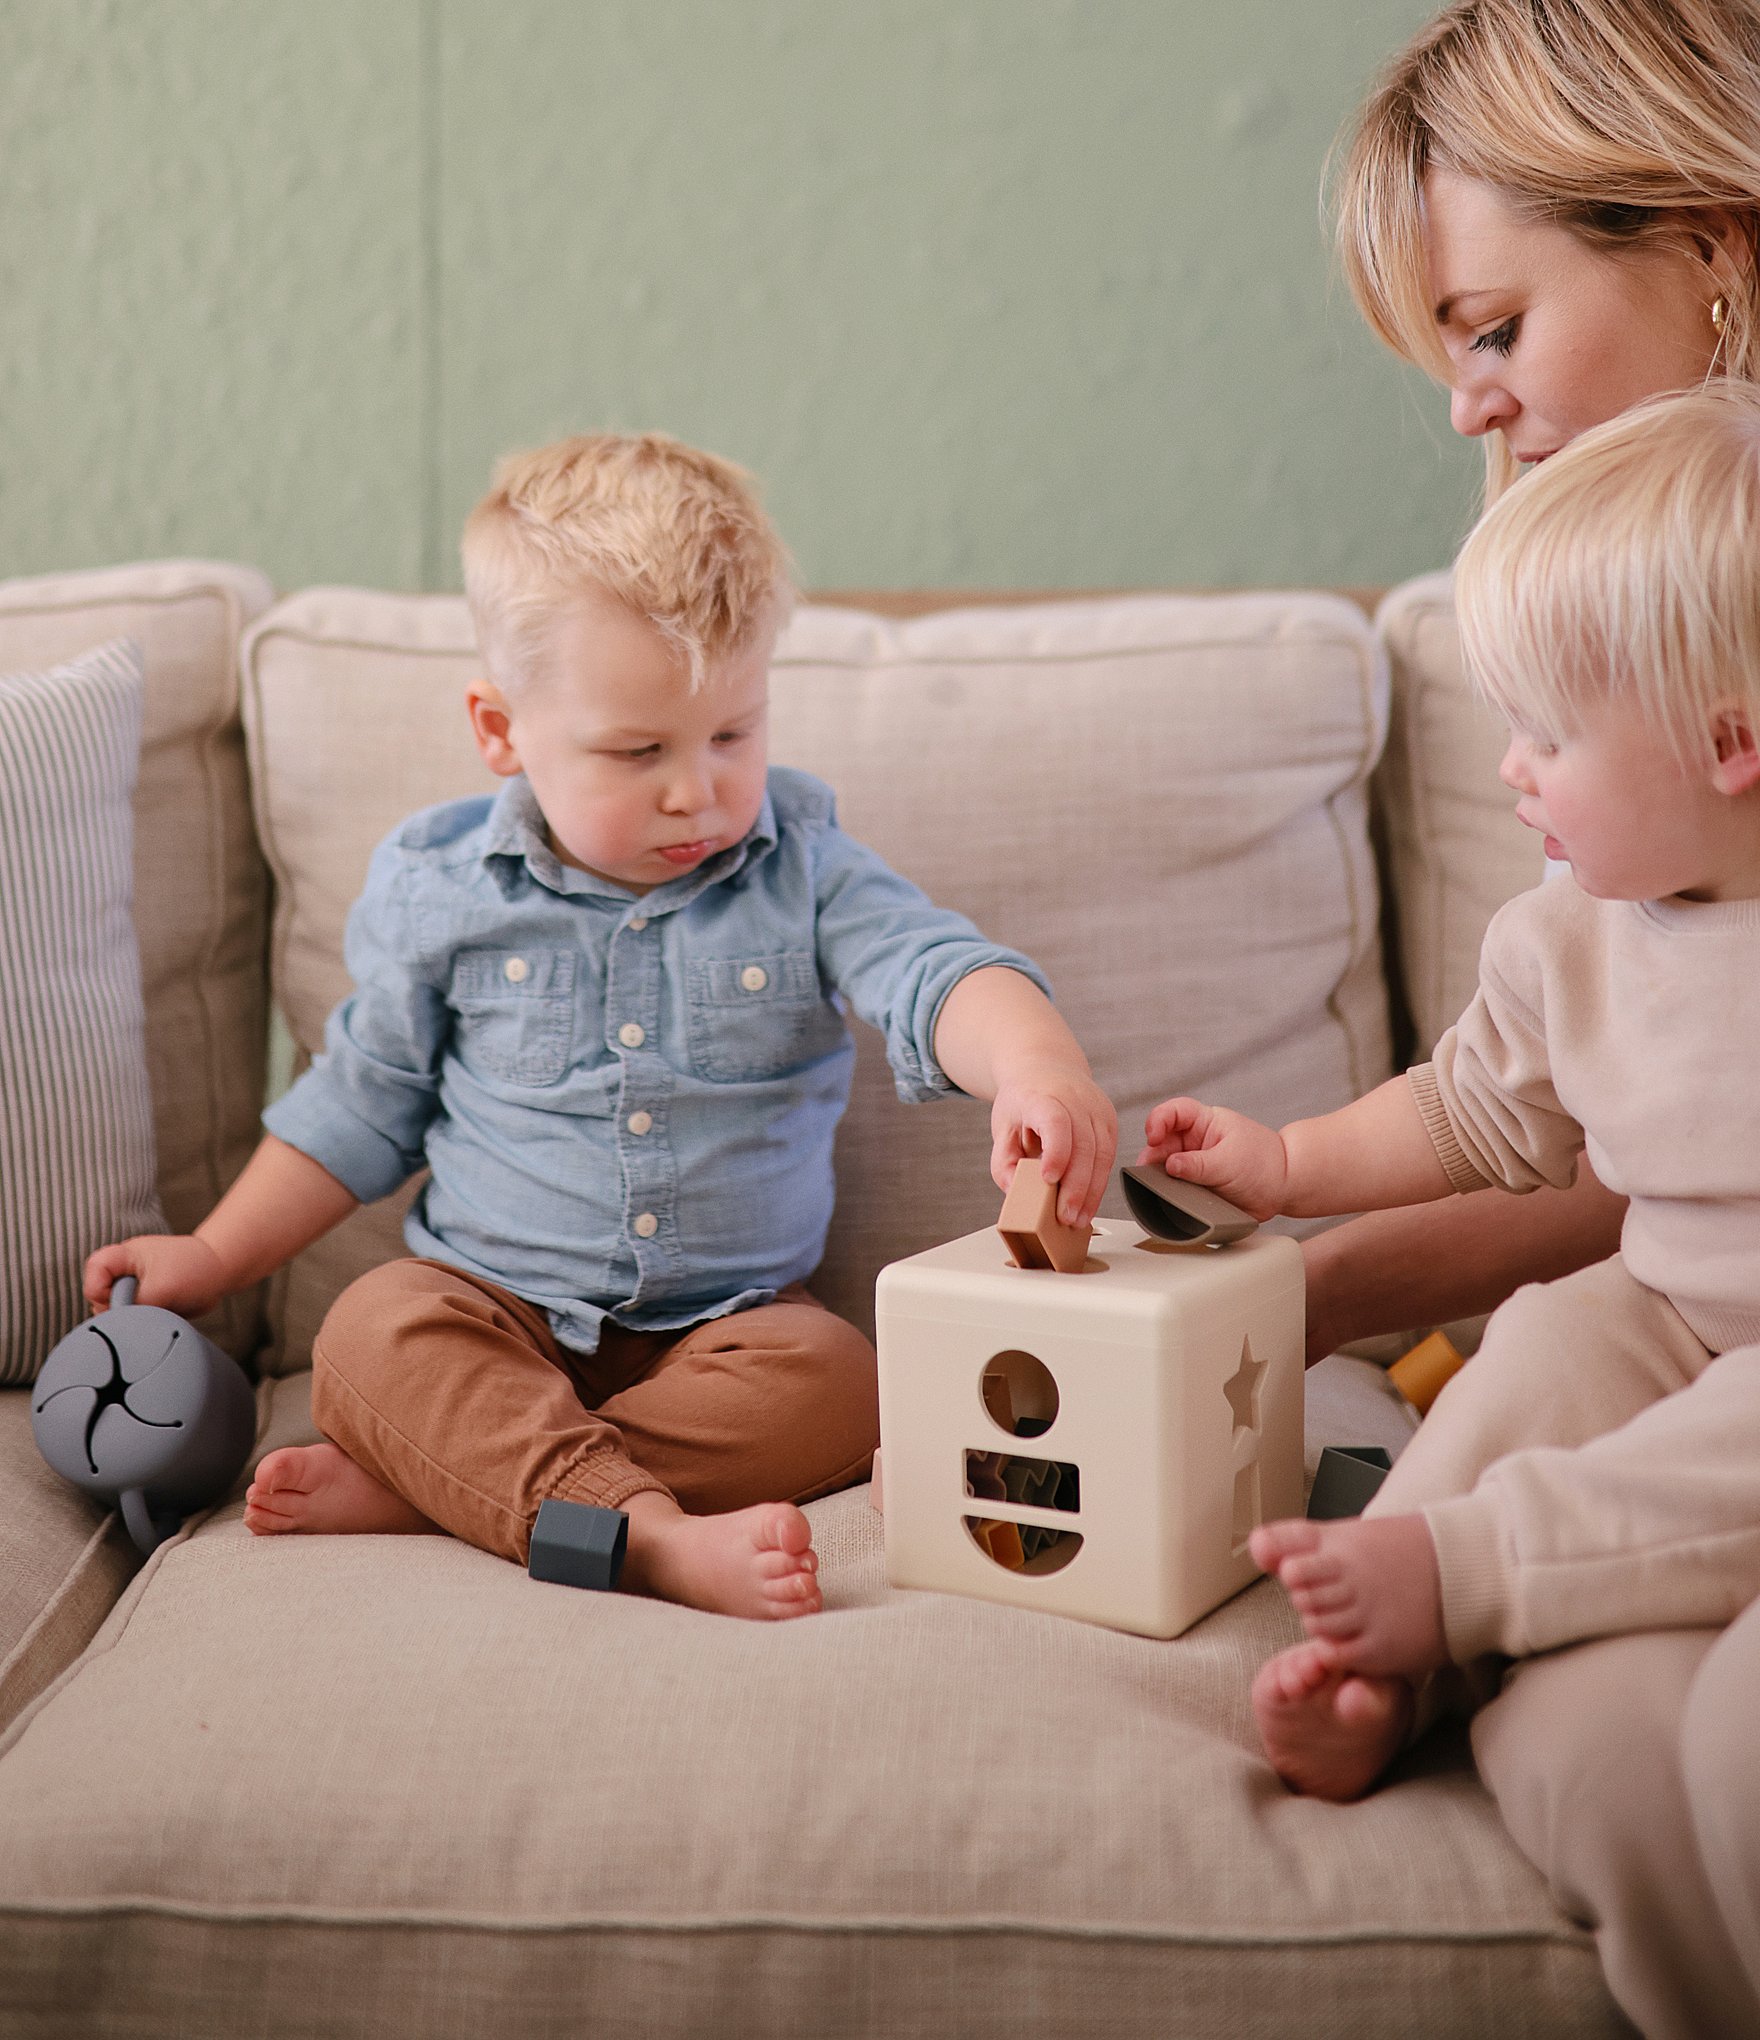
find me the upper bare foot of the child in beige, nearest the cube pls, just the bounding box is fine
[1250,1516,1448,1677]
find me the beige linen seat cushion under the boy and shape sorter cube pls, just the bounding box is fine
[0,1381,1623,2040]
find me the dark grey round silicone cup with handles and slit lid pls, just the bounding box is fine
[31,1275,257,1554]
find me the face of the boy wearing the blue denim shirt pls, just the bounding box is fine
[469,596,773,894]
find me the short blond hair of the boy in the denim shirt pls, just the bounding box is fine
[461,432,791,692]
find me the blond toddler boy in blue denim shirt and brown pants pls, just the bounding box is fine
[86,435,1116,1618]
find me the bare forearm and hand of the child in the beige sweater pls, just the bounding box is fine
[1138,1077,1454,1218]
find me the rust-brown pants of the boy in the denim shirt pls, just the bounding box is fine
[312,1261,879,1565]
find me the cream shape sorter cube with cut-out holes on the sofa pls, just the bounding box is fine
[875,1220,1303,1636]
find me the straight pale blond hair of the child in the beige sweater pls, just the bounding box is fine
[1454,381,1760,769]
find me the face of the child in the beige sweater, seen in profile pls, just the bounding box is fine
[1499,702,1760,900]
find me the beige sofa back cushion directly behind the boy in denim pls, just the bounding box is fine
[243,590,1389,1371]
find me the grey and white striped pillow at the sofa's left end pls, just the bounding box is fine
[0,639,165,1381]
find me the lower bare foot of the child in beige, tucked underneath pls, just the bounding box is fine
[1252,1644,1415,1799]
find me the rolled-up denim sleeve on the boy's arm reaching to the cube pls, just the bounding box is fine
[816,818,1050,1104]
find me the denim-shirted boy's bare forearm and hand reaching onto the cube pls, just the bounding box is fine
[934,965,1118,1226]
